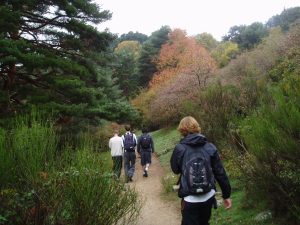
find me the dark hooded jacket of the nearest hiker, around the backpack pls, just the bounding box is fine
[170,133,231,199]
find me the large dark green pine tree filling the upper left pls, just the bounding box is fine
[0,0,138,123]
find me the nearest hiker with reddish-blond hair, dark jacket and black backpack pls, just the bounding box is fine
[170,116,232,225]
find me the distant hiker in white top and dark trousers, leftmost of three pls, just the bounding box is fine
[108,129,123,178]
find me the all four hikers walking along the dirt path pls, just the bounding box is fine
[109,116,232,225]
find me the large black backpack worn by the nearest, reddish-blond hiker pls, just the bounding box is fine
[179,145,214,197]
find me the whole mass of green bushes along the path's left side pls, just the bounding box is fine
[0,112,140,225]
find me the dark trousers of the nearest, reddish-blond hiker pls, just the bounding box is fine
[181,197,214,225]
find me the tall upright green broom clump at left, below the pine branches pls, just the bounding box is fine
[10,113,57,186]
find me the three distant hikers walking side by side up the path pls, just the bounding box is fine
[108,125,154,183]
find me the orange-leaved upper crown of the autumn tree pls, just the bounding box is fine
[150,29,216,88]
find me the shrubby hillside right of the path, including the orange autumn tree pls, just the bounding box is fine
[132,7,300,224]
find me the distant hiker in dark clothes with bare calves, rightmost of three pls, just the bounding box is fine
[137,128,154,177]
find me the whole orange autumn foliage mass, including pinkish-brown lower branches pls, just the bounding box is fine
[133,29,216,125]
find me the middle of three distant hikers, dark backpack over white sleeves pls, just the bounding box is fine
[122,125,137,183]
